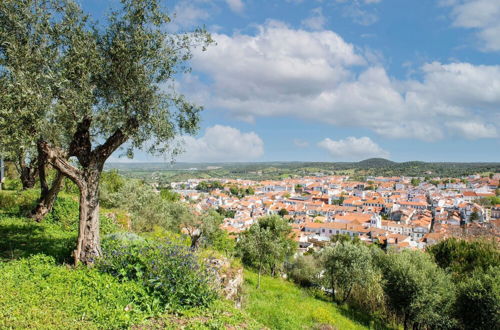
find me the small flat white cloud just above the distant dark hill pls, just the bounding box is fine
[318,136,389,160]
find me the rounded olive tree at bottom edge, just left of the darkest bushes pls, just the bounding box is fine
[380,250,456,329]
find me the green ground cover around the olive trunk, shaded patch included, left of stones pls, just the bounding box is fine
[0,210,262,329]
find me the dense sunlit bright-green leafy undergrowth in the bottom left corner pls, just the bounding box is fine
[0,255,158,329]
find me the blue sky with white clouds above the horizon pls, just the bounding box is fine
[81,0,500,162]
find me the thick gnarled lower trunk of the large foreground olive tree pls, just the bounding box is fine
[74,167,102,265]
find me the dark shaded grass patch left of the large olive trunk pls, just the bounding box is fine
[0,216,76,263]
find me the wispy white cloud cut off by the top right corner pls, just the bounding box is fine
[441,0,500,51]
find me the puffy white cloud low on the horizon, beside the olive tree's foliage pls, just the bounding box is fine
[179,125,264,162]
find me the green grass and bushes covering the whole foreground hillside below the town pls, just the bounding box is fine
[0,173,500,330]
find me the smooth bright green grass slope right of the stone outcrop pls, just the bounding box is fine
[243,270,390,330]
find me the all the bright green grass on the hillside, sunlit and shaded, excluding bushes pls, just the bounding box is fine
[0,191,378,329]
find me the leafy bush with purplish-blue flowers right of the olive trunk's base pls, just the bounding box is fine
[97,235,217,310]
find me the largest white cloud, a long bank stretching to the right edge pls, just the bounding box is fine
[184,22,500,141]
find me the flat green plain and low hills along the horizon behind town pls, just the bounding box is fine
[106,158,500,184]
